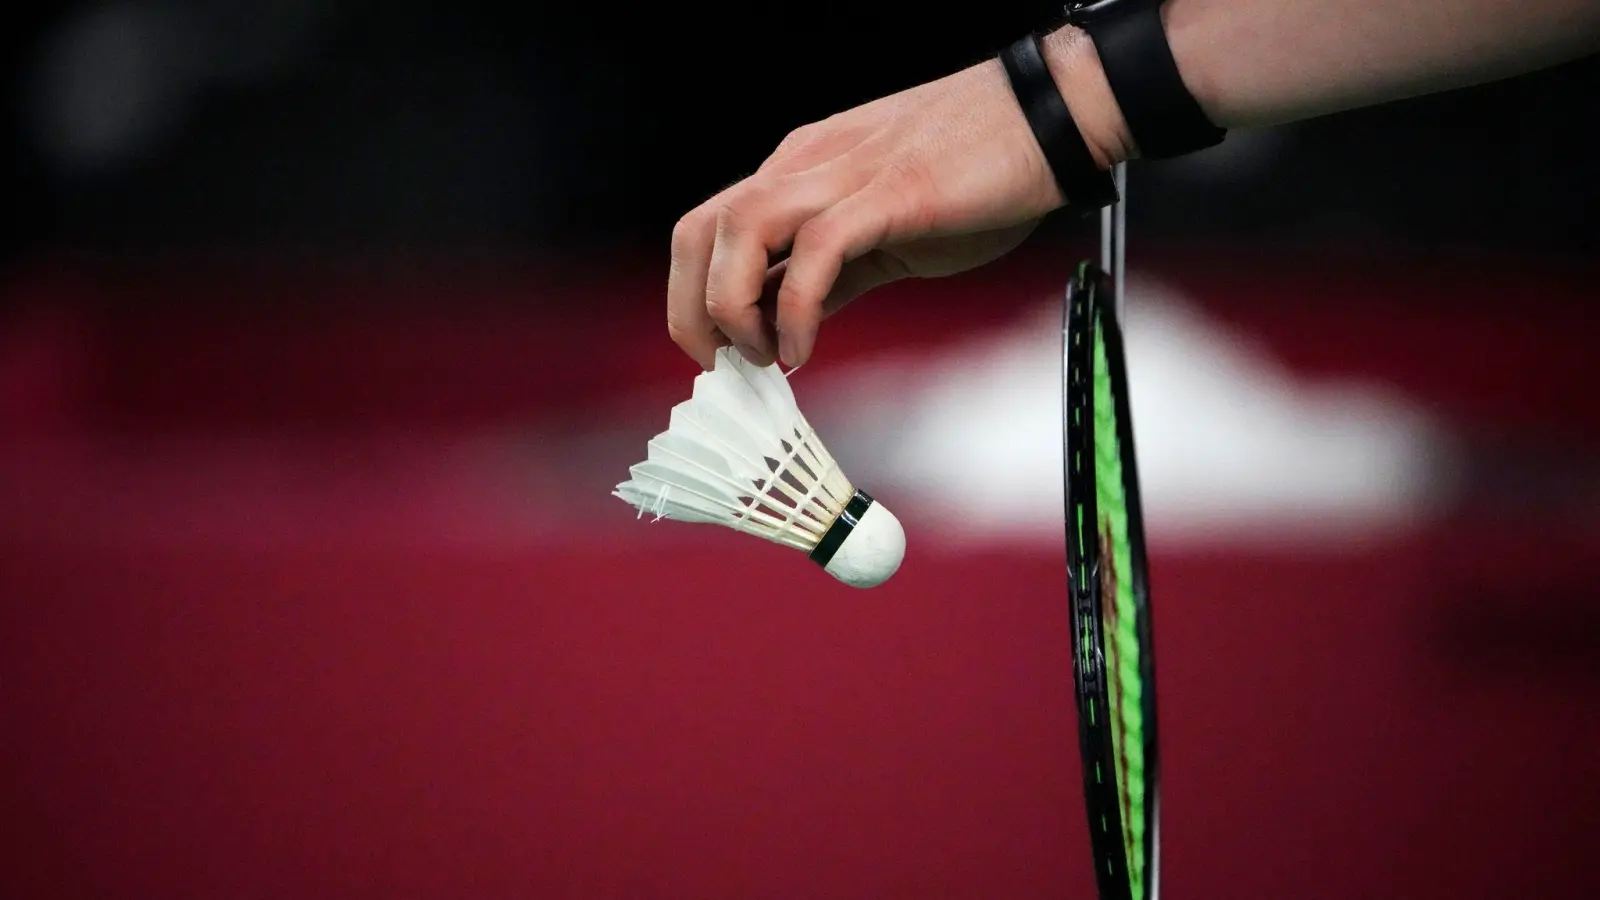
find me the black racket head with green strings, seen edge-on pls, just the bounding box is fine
[1062,263,1160,900]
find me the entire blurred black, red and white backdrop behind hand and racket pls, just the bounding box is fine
[0,0,1600,900]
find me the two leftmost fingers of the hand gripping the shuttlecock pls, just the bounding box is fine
[667,167,851,368]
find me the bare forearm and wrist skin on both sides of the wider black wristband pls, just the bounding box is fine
[1046,0,1600,159]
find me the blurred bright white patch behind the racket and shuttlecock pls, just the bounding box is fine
[806,280,1450,543]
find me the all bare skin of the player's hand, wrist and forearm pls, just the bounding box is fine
[667,0,1600,368]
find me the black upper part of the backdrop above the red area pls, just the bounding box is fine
[5,0,1600,253]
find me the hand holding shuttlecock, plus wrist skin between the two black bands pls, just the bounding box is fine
[667,30,1115,368]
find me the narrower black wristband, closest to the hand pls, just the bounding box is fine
[1000,34,1117,215]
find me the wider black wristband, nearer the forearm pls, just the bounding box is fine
[1067,0,1227,160]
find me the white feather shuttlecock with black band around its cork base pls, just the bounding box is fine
[614,348,906,588]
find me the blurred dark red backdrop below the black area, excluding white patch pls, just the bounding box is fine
[0,246,1600,900]
